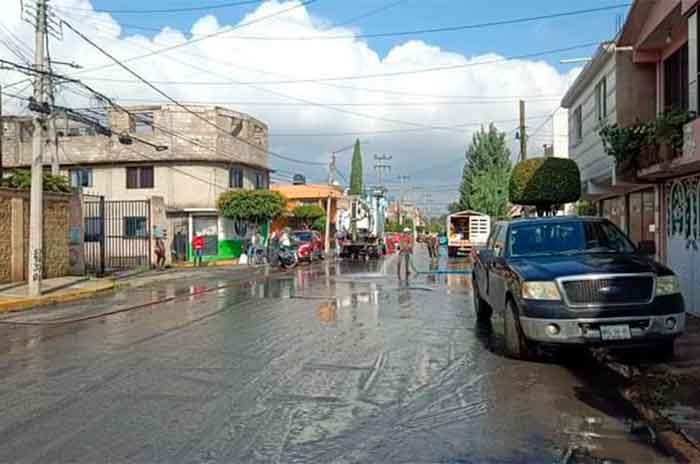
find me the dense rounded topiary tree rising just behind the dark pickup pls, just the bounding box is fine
[509,157,581,216]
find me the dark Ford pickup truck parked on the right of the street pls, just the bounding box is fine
[472,217,685,359]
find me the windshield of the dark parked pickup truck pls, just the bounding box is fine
[508,221,635,257]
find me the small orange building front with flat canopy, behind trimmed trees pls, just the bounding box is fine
[270,184,343,232]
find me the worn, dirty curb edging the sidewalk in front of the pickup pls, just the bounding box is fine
[594,352,700,463]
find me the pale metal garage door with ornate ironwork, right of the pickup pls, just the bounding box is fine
[666,177,700,315]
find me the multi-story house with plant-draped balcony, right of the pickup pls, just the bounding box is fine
[562,0,700,313]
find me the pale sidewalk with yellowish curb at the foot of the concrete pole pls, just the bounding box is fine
[0,277,115,313]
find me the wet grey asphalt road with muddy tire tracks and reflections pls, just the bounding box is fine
[0,255,671,463]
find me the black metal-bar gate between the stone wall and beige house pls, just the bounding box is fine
[83,195,151,275]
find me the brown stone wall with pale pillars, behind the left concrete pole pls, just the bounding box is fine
[0,188,80,283]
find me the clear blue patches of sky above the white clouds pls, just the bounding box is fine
[86,0,627,69]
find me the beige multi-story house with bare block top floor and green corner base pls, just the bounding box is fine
[2,105,269,259]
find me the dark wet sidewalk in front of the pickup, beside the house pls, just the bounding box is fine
[599,316,700,463]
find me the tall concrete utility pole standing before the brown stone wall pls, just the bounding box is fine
[27,0,47,296]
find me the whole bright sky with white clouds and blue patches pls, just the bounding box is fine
[0,0,625,210]
